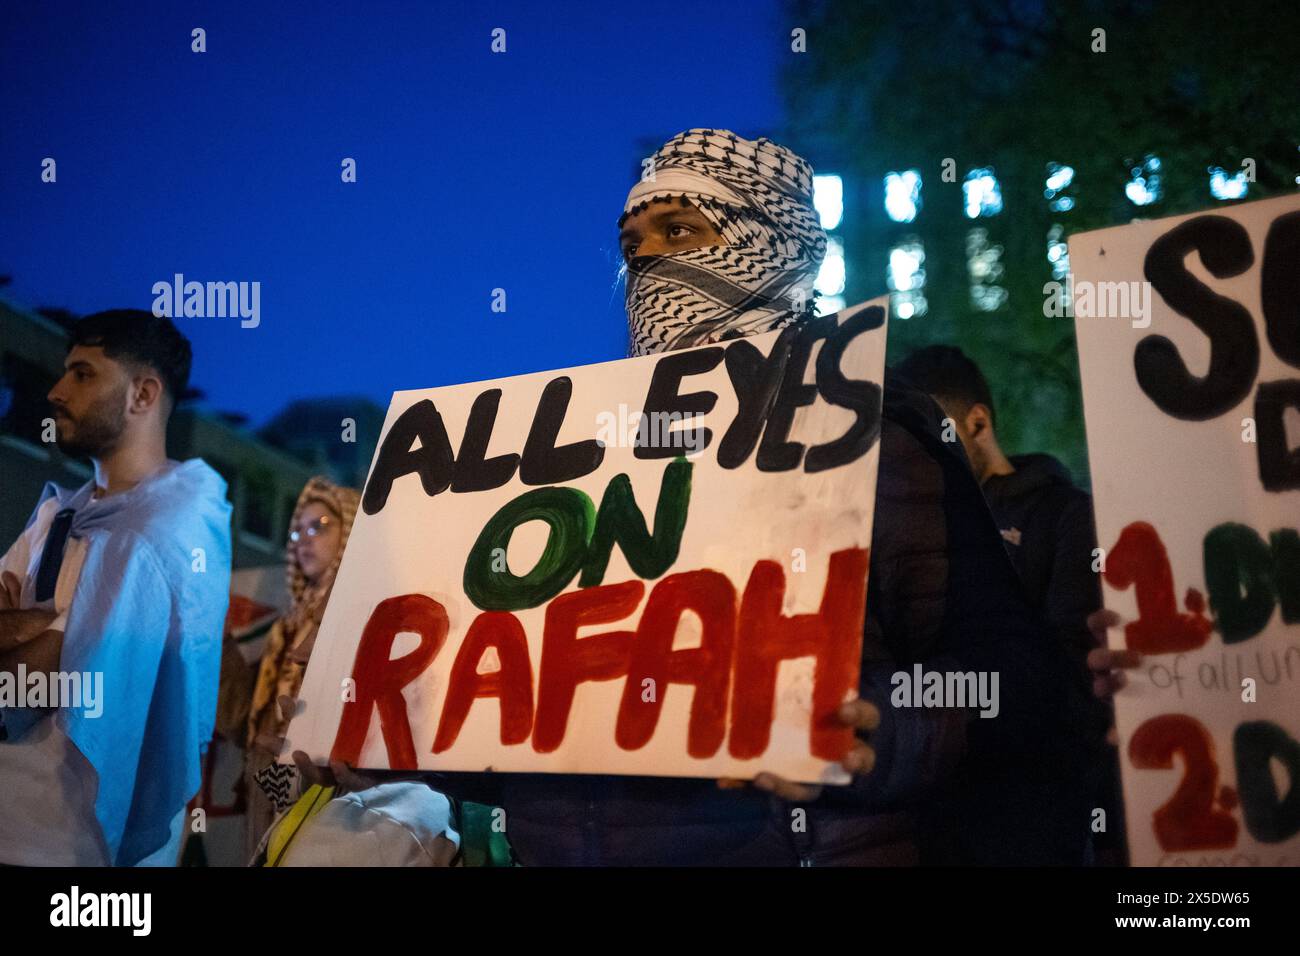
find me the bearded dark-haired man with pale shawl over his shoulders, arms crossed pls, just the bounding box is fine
[0,310,230,866]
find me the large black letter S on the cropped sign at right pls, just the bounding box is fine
[1134,216,1260,421]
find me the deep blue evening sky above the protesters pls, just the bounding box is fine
[0,0,790,423]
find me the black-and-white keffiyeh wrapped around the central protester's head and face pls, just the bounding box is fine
[619,129,826,355]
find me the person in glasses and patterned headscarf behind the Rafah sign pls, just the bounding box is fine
[244,476,360,857]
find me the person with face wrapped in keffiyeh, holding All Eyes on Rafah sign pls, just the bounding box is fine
[330,129,1088,866]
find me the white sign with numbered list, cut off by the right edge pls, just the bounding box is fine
[1070,196,1300,865]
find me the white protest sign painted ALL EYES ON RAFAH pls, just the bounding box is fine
[282,299,887,783]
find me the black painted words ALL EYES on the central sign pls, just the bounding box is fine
[361,307,884,515]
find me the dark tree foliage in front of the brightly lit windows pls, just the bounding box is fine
[783,0,1300,479]
